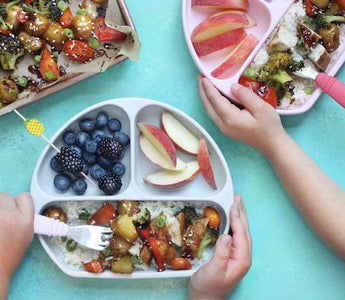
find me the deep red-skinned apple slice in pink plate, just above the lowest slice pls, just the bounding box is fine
[193,28,246,57]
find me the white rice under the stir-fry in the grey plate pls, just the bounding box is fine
[50,201,213,271]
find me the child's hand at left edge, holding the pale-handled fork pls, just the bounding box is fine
[0,193,34,286]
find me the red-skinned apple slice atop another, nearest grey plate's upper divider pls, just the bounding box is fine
[137,122,176,168]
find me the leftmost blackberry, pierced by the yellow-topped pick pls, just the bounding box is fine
[55,147,84,174]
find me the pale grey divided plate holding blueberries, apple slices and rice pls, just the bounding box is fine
[31,98,233,278]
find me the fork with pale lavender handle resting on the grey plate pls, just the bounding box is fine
[34,214,113,250]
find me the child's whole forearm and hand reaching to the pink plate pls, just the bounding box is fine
[199,78,345,259]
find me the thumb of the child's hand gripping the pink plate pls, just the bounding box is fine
[231,83,270,115]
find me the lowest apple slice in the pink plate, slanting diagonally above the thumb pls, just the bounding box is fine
[211,34,258,79]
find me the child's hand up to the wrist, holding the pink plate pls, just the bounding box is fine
[199,77,286,153]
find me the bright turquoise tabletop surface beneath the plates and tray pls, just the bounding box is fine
[0,0,345,300]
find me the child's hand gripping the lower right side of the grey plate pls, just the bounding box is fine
[189,195,252,300]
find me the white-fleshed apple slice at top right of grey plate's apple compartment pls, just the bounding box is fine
[161,111,199,156]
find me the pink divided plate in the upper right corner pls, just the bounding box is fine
[182,0,345,115]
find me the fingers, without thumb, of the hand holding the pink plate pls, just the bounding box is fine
[201,78,241,123]
